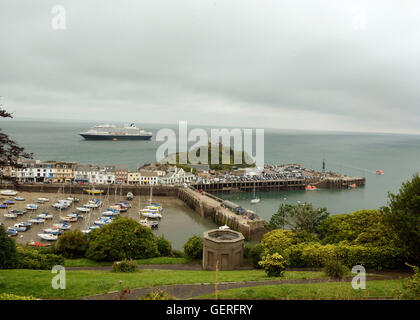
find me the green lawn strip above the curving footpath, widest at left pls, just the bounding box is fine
[0,269,325,299]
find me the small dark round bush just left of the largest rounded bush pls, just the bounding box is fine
[55,230,89,259]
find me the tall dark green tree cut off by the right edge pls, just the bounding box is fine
[382,173,420,264]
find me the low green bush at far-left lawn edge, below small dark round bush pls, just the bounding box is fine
[17,246,64,270]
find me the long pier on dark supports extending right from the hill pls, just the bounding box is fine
[194,177,366,193]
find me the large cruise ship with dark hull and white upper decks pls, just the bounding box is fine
[79,123,152,140]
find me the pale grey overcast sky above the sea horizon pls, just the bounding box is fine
[0,0,420,133]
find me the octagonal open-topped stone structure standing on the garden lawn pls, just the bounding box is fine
[203,229,245,270]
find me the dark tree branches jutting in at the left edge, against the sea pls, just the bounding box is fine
[0,104,32,182]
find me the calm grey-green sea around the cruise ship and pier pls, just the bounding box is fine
[0,119,420,218]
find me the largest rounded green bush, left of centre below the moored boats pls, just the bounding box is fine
[86,218,159,261]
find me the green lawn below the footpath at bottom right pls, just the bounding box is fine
[195,280,402,300]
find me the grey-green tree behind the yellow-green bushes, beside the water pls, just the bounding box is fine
[268,203,329,234]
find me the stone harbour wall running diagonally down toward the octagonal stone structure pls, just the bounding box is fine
[178,188,265,241]
